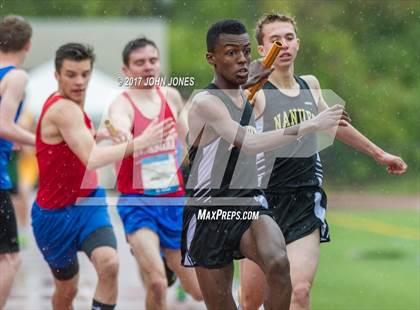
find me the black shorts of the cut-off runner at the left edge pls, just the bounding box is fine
[0,190,19,254]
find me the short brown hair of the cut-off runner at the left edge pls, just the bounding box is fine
[0,15,32,53]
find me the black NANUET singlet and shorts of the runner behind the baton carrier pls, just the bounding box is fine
[257,77,329,243]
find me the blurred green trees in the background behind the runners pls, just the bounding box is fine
[0,0,420,192]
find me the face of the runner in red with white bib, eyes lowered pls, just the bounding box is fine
[123,45,160,87]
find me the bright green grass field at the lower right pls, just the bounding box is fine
[312,210,420,310]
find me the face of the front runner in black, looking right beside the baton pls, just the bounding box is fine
[207,33,251,86]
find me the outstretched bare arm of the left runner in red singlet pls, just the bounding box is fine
[51,99,173,169]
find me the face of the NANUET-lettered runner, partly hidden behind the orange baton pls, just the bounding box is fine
[259,21,299,68]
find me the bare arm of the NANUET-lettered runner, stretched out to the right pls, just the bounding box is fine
[307,76,407,175]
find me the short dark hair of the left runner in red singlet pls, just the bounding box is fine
[55,43,95,71]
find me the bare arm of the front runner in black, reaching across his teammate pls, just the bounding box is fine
[191,94,343,154]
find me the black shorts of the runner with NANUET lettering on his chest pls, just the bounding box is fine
[266,187,330,244]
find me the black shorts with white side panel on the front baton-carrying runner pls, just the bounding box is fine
[181,196,271,269]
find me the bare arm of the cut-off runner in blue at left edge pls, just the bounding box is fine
[0,70,35,145]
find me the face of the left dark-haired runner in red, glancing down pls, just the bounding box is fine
[55,59,92,103]
